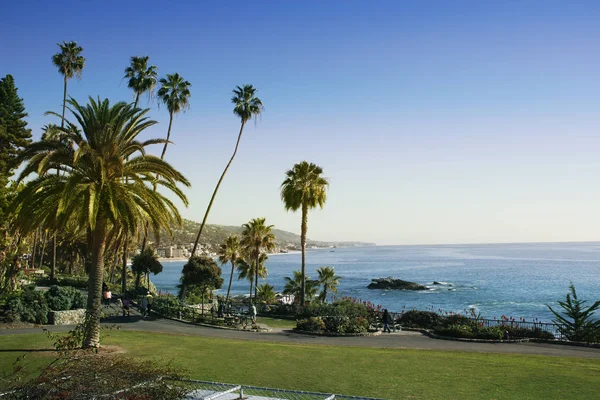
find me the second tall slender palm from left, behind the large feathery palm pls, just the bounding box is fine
[121,56,159,284]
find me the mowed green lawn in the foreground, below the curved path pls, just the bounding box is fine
[0,331,600,399]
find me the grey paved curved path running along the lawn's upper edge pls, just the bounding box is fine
[0,315,600,359]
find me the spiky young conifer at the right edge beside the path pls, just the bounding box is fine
[547,284,600,342]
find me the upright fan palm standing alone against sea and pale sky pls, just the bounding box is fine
[281,161,329,304]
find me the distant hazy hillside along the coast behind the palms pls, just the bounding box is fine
[161,219,375,250]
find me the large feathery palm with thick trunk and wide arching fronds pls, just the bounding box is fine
[13,98,189,347]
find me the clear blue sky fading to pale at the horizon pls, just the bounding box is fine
[0,0,600,244]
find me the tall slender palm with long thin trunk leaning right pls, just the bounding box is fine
[192,85,264,254]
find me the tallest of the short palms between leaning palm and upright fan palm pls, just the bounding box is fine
[241,218,275,297]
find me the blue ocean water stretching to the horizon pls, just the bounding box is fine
[152,242,600,322]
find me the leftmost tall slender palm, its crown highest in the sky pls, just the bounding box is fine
[50,42,85,279]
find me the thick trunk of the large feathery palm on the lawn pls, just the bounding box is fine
[83,216,106,348]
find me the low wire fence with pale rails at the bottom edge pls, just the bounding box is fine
[184,380,382,400]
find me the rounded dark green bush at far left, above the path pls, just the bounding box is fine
[5,285,48,324]
